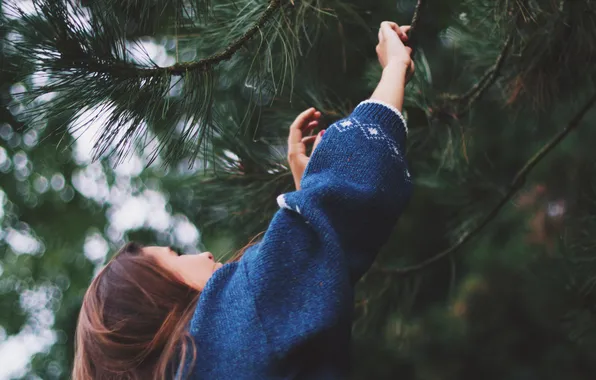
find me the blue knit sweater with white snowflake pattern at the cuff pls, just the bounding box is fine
[188,101,411,380]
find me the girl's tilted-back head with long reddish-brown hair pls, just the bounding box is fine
[73,243,222,380]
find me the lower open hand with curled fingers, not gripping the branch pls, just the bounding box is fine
[288,108,325,190]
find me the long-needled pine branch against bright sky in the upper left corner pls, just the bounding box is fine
[3,0,295,164]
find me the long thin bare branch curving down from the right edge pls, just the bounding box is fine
[375,94,596,276]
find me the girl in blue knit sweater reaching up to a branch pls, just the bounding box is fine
[73,22,414,380]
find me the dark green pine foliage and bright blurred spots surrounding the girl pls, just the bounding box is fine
[0,0,596,380]
